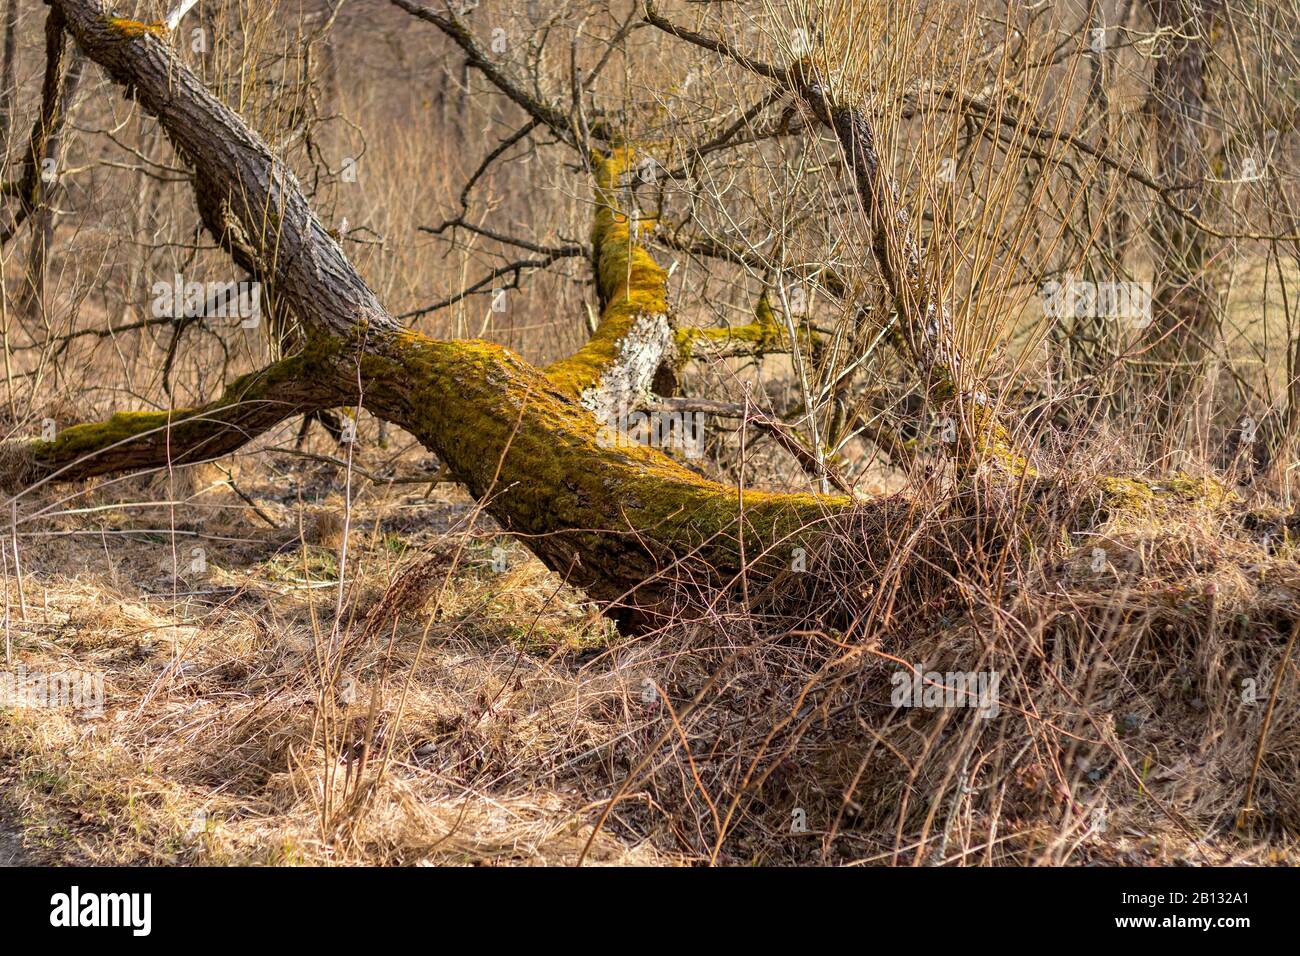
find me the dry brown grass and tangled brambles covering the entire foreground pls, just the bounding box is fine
[0,418,1300,865]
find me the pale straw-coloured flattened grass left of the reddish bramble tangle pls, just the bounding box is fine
[0,434,677,864]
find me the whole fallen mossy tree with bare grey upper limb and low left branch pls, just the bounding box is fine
[2,0,873,629]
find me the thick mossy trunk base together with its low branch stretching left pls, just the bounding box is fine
[25,333,863,620]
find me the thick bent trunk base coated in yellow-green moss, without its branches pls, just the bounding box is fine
[361,334,853,597]
